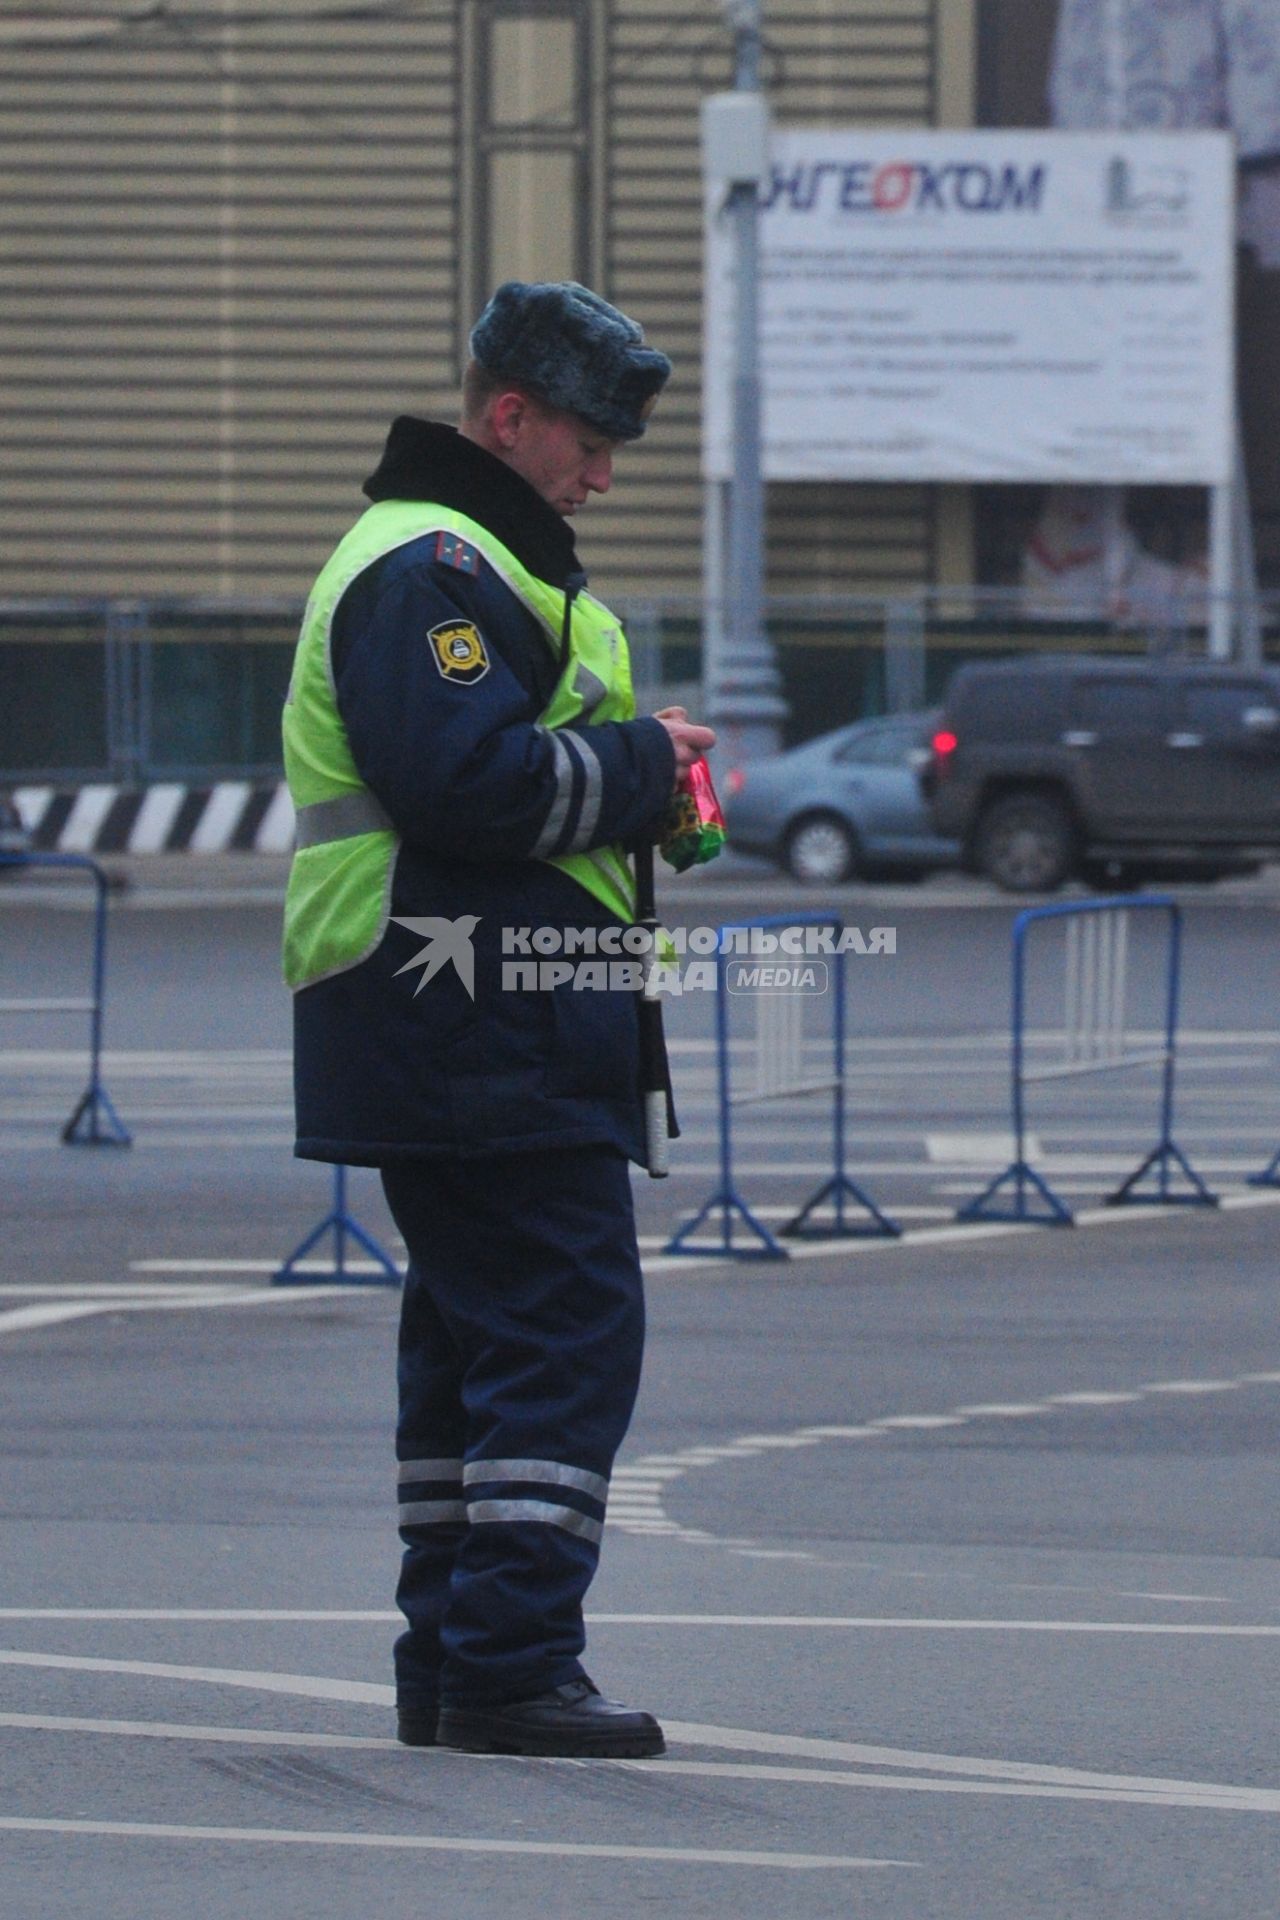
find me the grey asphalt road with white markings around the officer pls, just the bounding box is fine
[0,874,1280,1920]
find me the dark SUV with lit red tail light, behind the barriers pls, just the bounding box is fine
[921,655,1280,893]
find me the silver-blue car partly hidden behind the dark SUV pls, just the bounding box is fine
[718,712,960,885]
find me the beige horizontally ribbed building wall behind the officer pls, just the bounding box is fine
[0,0,973,597]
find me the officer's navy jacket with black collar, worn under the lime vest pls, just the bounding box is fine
[294,417,676,1165]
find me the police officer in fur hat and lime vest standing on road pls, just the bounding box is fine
[284,282,714,1755]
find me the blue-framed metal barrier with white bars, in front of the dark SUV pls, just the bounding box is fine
[956,895,1219,1227]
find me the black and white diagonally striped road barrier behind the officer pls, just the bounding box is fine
[12,780,294,852]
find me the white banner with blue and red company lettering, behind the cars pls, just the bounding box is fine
[704,129,1236,486]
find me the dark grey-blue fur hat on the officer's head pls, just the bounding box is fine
[470,280,672,440]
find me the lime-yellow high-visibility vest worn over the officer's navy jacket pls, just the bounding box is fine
[284,499,635,989]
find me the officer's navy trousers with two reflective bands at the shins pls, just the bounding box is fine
[382,1146,645,1711]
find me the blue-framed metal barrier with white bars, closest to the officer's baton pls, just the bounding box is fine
[664,914,902,1260]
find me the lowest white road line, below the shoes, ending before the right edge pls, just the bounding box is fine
[0,1818,905,1872]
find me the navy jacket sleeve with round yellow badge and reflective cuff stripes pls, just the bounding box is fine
[336,564,676,860]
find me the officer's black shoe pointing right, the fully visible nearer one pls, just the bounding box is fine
[435,1676,666,1759]
